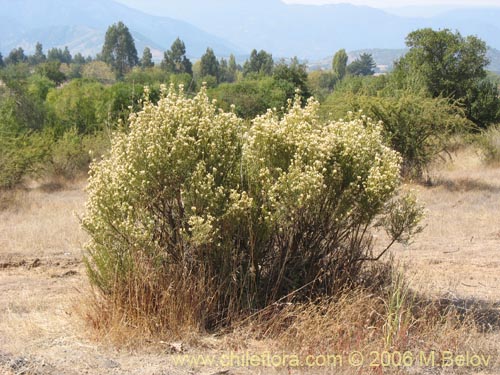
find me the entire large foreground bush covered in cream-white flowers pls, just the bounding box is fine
[83,87,421,333]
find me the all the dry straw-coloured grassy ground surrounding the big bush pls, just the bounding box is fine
[0,150,500,375]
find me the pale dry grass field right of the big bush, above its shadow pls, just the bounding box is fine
[393,149,500,301]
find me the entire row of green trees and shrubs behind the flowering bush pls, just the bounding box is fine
[0,23,500,188]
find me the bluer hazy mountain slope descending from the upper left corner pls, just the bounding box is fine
[0,0,238,57]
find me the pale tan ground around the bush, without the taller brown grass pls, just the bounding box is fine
[0,152,500,375]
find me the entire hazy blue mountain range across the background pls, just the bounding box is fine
[0,0,500,70]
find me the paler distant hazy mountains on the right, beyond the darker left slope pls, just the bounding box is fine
[117,0,500,60]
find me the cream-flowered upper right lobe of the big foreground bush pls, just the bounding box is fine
[243,94,401,226]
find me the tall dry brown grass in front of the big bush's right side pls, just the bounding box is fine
[232,274,477,355]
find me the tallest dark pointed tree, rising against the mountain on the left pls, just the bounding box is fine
[101,21,139,78]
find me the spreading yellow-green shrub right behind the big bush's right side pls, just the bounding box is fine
[324,93,469,178]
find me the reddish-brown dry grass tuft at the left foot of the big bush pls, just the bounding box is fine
[78,273,216,346]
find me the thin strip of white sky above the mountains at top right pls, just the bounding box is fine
[284,0,500,8]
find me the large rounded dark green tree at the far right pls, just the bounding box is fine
[395,28,498,125]
